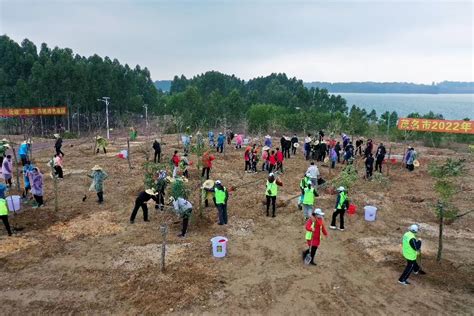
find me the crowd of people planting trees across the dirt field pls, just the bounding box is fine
[0,130,424,285]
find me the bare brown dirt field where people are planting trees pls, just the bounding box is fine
[0,135,474,315]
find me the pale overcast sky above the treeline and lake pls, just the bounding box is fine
[0,0,474,83]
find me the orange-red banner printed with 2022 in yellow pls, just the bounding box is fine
[398,118,474,134]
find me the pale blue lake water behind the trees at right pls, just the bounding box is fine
[332,93,474,120]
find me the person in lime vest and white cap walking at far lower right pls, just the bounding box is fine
[398,224,426,285]
